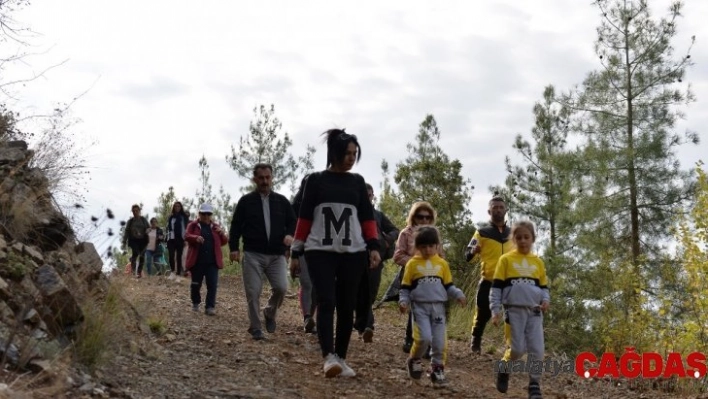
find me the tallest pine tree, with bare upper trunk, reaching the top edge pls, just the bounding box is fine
[566,0,698,347]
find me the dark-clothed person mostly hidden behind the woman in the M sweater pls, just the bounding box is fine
[354,183,398,343]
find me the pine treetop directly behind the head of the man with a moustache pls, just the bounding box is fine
[226,105,315,192]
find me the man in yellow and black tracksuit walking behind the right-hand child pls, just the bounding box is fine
[465,196,514,354]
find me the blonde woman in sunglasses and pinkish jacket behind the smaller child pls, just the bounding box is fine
[393,201,445,353]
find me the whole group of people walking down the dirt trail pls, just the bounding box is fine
[124,129,550,398]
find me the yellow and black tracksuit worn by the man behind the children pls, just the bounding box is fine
[467,222,514,350]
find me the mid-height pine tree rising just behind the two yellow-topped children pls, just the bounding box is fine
[490,86,587,350]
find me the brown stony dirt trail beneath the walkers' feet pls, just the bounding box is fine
[85,276,684,399]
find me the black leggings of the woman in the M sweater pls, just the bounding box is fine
[305,251,368,359]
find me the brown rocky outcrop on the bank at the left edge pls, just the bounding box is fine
[0,141,108,371]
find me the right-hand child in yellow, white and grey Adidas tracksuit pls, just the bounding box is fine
[489,221,551,399]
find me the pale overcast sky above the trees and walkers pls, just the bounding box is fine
[3,0,708,256]
